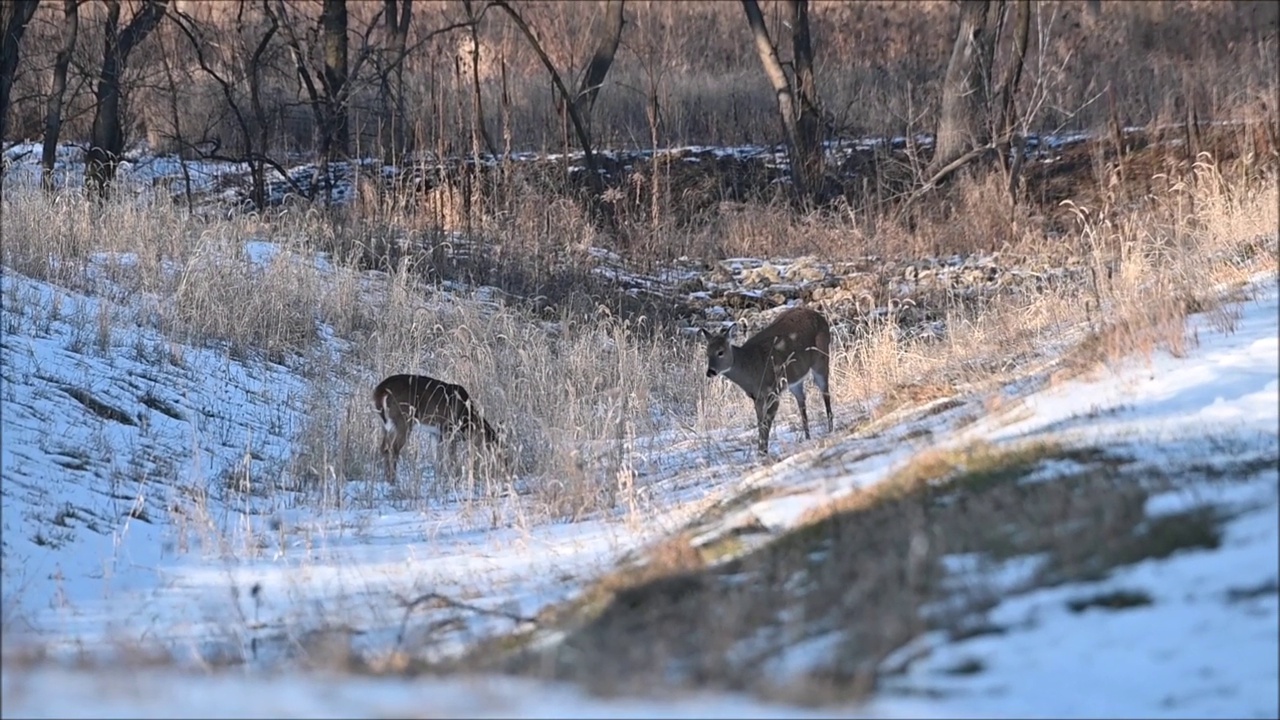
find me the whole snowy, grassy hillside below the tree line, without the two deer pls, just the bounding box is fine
[0,120,1280,716]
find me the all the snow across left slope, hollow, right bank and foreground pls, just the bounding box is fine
[3,265,1280,717]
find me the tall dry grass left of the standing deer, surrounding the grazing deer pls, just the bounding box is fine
[3,181,698,519]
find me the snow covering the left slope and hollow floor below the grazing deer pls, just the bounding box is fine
[0,265,731,666]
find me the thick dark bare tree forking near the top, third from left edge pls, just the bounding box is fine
[84,0,169,197]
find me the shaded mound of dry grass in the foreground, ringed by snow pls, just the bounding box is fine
[468,435,1265,703]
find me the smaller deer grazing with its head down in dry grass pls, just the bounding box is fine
[374,375,498,482]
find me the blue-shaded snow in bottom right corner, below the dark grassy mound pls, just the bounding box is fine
[891,499,1280,717]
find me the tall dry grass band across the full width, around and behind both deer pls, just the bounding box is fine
[0,121,1277,519]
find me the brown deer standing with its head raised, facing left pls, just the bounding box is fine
[701,307,833,455]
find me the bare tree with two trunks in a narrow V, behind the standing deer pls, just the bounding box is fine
[742,0,823,204]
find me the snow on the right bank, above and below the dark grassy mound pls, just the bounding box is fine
[699,277,1280,717]
